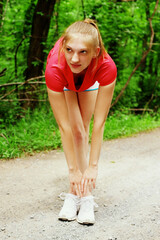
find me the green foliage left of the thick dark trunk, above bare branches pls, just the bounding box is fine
[0,0,33,83]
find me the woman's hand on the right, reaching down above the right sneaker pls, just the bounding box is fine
[81,166,98,196]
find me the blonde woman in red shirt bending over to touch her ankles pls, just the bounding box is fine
[45,19,117,224]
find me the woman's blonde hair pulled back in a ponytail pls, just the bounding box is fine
[59,19,106,59]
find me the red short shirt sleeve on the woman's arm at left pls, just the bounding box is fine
[45,65,66,92]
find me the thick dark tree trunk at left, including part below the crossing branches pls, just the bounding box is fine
[20,0,56,109]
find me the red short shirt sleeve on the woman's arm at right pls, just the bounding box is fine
[95,58,117,86]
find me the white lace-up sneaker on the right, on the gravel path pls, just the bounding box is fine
[77,196,98,225]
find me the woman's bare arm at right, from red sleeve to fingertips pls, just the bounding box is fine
[81,81,115,194]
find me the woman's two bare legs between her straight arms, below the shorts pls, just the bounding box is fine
[65,91,98,173]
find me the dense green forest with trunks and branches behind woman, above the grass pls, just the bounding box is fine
[0,0,160,157]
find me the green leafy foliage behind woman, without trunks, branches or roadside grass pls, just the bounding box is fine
[0,0,160,110]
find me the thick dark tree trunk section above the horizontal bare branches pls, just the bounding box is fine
[26,0,56,79]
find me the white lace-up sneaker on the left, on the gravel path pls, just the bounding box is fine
[58,193,79,221]
